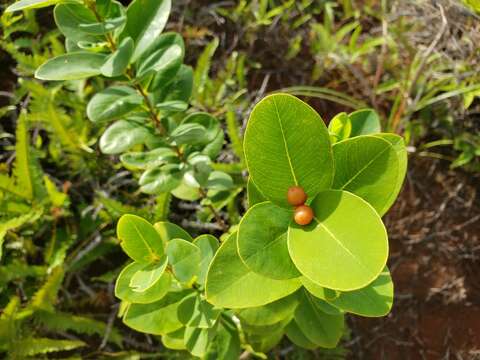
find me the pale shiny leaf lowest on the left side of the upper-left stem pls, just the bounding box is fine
[138,164,183,194]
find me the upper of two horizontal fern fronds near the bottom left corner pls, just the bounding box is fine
[34,310,122,346]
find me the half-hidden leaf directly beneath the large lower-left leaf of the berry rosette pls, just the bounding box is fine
[237,294,298,326]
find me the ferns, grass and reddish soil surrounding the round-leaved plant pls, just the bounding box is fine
[0,0,480,359]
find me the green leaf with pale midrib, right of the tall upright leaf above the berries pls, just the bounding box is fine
[332,135,399,216]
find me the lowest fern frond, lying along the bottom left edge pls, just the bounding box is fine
[15,338,86,357]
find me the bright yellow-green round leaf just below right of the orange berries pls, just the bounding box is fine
[288,190,388,291]
